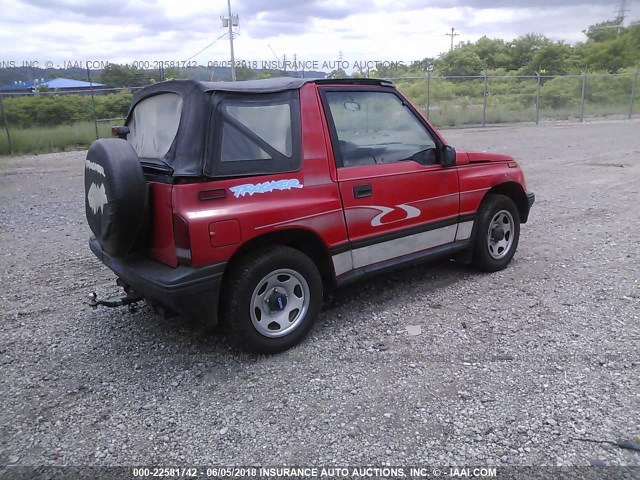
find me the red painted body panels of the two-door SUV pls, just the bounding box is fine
[147,83,526,278]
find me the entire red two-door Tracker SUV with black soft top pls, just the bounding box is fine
[85,78,534,353]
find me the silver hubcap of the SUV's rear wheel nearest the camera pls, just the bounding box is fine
[251,268,311,338]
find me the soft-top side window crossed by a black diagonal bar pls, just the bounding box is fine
[207,91,300,175]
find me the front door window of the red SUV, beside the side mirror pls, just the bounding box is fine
[325,91,436,167]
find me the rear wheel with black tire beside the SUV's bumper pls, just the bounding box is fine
[221,246,323,354]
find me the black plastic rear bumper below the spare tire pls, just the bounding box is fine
[89,237,226,323]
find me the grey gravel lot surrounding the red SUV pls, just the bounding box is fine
[0,120,640,468]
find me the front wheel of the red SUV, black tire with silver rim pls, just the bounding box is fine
[472,194,520,272]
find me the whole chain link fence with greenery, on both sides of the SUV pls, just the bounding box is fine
[0,71,640,155]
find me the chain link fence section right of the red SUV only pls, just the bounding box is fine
[388,71,640,126]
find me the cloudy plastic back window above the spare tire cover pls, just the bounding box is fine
[127,93,182,158]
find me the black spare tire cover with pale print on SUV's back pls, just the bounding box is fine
[84,138,148,257]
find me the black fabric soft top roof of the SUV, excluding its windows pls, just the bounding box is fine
[125,77,393,177]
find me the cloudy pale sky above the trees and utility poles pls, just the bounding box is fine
[0,0,640,68]
